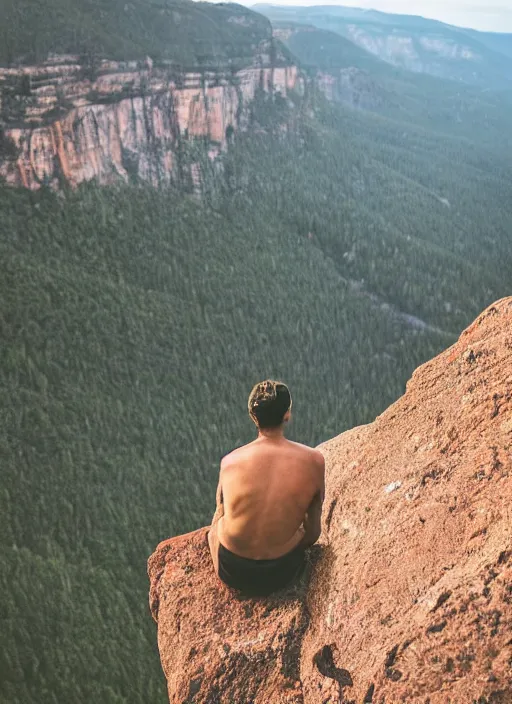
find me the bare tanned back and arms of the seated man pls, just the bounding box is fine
[218,436,324,560]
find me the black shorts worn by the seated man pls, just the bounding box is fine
[219,544,304,596]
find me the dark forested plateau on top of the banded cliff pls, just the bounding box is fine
[0,0,271,68]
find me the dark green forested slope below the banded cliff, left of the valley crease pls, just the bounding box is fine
[0,182,444,704]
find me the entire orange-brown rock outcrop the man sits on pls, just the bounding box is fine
[149,298,512,704]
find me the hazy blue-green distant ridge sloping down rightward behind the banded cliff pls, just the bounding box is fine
[274,22,512,146]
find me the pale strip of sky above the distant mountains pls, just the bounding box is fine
[254,0,512,32]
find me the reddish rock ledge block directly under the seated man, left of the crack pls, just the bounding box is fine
[149,529,318,704]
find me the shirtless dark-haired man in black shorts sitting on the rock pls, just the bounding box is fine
[208,380,325,596]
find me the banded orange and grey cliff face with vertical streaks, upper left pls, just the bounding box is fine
[0,55,301,189]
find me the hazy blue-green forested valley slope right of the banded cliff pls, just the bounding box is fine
[226,92,512,332]
